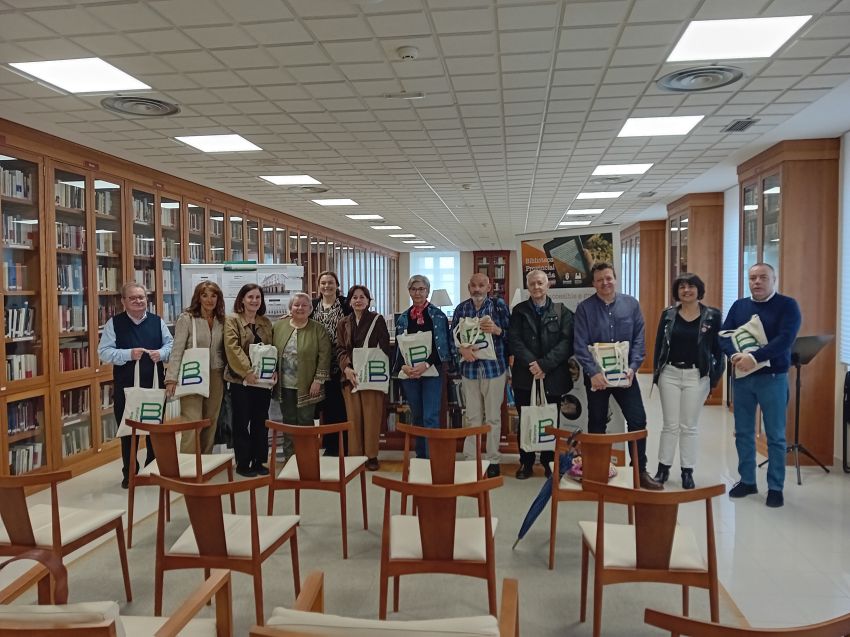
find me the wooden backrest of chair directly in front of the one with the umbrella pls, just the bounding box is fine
[582,479,726,571]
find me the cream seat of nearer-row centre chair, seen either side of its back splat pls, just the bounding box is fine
[390,515,499,562]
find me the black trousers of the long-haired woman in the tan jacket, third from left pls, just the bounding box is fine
[230,383,272,469]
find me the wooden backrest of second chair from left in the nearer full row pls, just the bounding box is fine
[151,475,269,557]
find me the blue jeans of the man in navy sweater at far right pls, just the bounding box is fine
[732,373,788,491]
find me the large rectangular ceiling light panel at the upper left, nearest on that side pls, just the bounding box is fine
[9,58,150,93]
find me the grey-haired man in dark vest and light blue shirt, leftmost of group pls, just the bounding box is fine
[97,283,174,489]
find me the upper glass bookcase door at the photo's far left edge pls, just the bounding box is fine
[0,151,45,382]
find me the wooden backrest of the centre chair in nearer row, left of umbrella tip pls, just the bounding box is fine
[372,475,496,560]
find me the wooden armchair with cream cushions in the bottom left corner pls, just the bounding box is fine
[0,550,233,637]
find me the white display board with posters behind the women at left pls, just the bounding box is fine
[180,263,304,320]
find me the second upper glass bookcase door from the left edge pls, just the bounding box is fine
[53,168,91,372]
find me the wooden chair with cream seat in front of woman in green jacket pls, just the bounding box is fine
[266,420,369,559]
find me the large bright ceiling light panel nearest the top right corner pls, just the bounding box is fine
[667,15,812,62]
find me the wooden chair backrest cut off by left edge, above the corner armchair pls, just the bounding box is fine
[0,471,71,549]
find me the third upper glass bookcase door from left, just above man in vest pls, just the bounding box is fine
[94,178,124,331]
